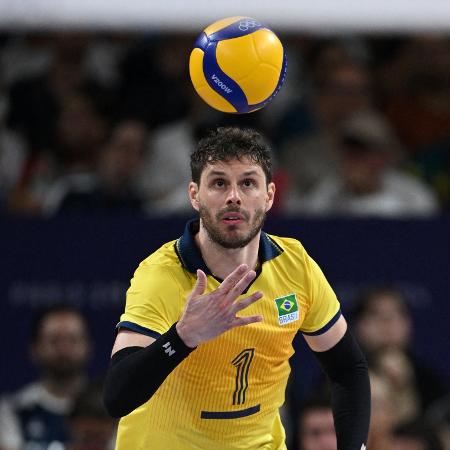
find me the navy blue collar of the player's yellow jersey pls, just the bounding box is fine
[175,219,283,275]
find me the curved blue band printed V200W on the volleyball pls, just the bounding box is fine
[203,42,248,113]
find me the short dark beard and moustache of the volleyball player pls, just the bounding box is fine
[198,204,266,249]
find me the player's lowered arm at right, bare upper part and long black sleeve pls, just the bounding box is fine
[304,315,370,450]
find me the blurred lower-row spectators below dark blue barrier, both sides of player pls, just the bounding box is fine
[0,286,450,450]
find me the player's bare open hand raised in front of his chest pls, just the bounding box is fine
[177,264,263,347]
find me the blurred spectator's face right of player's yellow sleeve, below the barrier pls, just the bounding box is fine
[356,293,411,351]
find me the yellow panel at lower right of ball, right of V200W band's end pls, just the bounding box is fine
[239,63,280,105]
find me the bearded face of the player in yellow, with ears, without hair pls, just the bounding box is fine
[189,158,275,248]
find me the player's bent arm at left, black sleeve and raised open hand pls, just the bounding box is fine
[103,265,262,417]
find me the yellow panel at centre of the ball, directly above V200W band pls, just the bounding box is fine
[216,34,259,82]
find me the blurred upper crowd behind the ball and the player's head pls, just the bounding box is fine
[0,32,450,218]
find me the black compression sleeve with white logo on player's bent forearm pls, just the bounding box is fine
[103,324,194,417]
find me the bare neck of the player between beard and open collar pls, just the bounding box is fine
[195,227,261,280]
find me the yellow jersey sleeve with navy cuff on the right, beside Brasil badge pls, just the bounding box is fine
[300,252,341,335]
